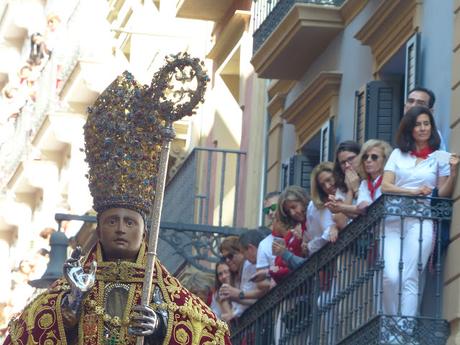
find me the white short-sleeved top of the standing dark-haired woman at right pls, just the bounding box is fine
[385,149,450,189]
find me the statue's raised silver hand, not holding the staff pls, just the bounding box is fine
[64,247,97,292]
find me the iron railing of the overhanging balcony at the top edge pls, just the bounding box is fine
[252,0,345,53]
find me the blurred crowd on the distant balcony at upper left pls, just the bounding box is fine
[0,14,61,147]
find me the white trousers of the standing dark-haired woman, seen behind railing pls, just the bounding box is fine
[382,217,433,316]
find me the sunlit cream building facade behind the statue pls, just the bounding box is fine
[0,0,265,331]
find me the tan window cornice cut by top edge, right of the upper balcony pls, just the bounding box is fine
[355,0,421,72]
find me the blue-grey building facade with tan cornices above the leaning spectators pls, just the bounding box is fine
[251,0,460,344]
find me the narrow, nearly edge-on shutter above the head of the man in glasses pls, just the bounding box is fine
[404,32,420,99]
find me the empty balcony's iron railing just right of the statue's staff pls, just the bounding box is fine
[147,147,245,273]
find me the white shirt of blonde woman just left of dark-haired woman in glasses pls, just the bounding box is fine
[307,201,335,255]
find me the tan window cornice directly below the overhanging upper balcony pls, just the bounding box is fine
[281,71,342,147]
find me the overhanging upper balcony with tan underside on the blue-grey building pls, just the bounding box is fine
[251,0,344,80]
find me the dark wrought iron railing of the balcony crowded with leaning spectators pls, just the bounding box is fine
[232,195,452,345]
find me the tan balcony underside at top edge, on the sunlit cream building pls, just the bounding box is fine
[176,0,234,22]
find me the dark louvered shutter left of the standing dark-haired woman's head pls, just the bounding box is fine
[364,80,402,145]
